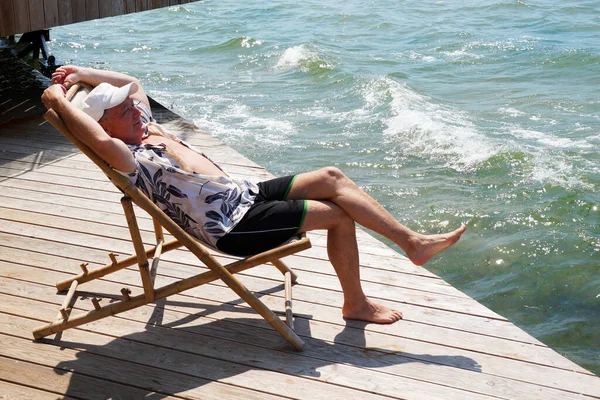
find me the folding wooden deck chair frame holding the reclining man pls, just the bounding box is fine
[33,85,311,350]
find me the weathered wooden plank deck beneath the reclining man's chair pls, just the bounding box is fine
[0,69,600,400]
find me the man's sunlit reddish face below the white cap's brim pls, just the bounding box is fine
[100,97,146,144]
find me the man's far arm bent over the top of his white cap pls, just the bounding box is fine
[52,65,150,109]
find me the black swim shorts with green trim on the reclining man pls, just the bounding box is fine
[216,176,308,257]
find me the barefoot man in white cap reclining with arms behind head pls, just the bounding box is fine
[42,66,466,323]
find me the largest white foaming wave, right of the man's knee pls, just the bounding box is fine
[364,77,595,190]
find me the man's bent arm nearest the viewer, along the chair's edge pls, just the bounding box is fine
[42,84,136,172]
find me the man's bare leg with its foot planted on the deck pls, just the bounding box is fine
[300,196,402,324]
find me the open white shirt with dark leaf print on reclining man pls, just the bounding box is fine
[115,103,259,247]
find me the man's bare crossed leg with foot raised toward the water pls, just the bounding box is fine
[287,167,466,265]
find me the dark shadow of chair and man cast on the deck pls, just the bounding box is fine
[43,289,481,399]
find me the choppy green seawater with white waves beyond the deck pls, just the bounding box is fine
[49,0,600,374]
